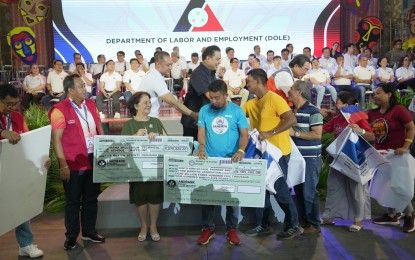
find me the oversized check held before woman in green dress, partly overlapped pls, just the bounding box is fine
[93,135,193,182]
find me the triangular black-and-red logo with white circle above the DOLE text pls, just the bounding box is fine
[173,0,223,32]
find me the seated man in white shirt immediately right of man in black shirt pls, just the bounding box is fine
[223,58,249,106]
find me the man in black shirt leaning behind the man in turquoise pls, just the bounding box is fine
[180,45,221,140]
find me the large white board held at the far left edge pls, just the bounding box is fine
[0,126,51,236]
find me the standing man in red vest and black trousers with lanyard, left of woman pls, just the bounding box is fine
[49,74,105,250]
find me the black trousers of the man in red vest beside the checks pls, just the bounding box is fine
[63,156,100,239]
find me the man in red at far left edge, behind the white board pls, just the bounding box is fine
[0,84,50,258]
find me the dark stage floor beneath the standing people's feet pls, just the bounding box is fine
[0,200,415,260]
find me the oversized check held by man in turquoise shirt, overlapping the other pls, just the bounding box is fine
[164,155,267,207]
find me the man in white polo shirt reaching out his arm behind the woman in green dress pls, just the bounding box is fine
[140,51,197,122]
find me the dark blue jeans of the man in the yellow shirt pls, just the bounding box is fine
[256,155,299,230]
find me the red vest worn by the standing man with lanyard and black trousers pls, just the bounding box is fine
[49,98,102,170]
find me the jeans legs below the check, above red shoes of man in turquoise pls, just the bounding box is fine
[202,205,238,231]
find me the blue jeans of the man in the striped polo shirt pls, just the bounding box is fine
[294,157,322,227]
